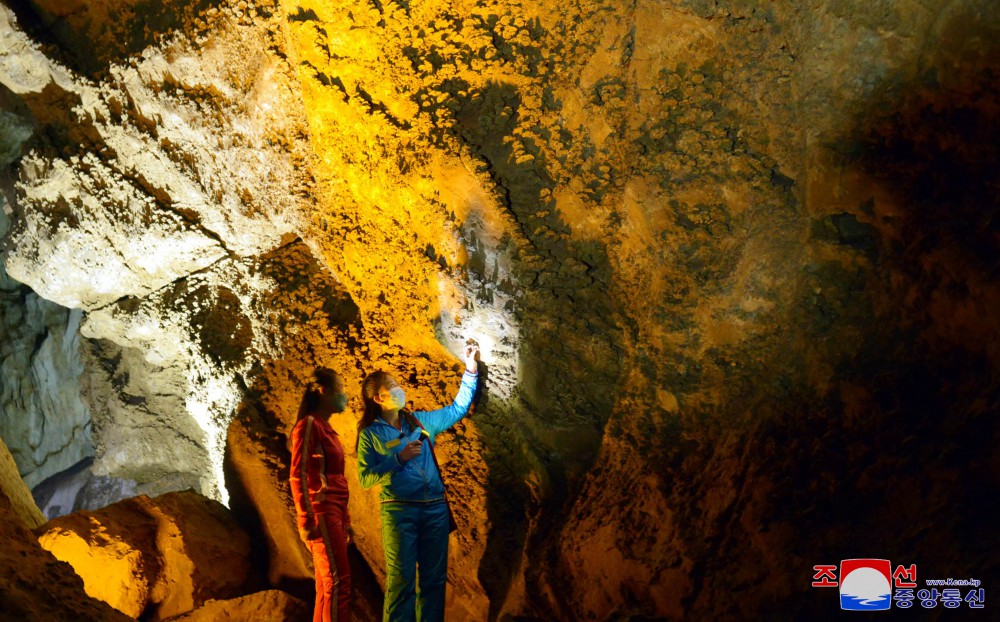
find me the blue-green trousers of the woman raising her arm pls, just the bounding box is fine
[382,501,449,622]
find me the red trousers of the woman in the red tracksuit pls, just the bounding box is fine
[306,514,351,622]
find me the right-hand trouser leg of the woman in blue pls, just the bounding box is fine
[417,503,450,622]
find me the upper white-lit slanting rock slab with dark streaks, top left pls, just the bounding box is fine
[0,4,304,308]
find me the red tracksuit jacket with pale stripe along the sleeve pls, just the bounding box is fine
[288,415,351,530]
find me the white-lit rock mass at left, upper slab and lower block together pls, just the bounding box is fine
[0,7,309,500]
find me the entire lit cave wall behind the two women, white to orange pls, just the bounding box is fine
[0,0,1000,620]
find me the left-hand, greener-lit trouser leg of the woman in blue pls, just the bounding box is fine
[382,503,420,622]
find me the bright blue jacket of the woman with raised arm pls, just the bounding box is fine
[358,371,479,503]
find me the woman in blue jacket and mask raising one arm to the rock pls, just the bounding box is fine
[358,345,479,622]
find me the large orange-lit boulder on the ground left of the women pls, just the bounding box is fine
[37,492,250,620]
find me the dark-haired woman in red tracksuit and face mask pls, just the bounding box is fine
[289,367,354,622]
